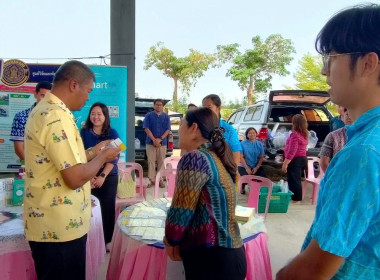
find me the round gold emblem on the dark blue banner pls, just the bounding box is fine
[1,59,30,87]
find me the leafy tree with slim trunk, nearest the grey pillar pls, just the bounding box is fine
[144,42,217,110]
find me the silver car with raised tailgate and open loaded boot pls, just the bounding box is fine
[228,90,333,163]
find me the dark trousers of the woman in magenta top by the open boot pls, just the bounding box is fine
[287,157,307,201]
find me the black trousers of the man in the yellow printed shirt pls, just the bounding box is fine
[29,234,87,280]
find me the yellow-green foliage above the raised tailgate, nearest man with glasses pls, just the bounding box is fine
[294,54,329,90]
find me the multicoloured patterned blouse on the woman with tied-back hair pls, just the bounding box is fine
[165,148,243,250]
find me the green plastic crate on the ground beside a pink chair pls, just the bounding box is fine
[259,186,293,213]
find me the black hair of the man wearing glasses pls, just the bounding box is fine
[315,4,380,70]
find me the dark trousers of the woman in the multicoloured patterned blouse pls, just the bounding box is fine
[181,246,247,280]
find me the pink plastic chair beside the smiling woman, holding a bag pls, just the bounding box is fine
[115,162,147,219]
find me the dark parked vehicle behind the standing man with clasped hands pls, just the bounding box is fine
[135,97,183,161]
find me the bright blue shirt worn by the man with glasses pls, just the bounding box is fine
[302,106,380,280]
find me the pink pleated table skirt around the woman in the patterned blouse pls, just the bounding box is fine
[107,226,272,280]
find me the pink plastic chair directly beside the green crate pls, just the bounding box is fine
[239,175,273,219]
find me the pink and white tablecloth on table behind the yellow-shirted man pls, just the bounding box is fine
[0,196,106,280]
